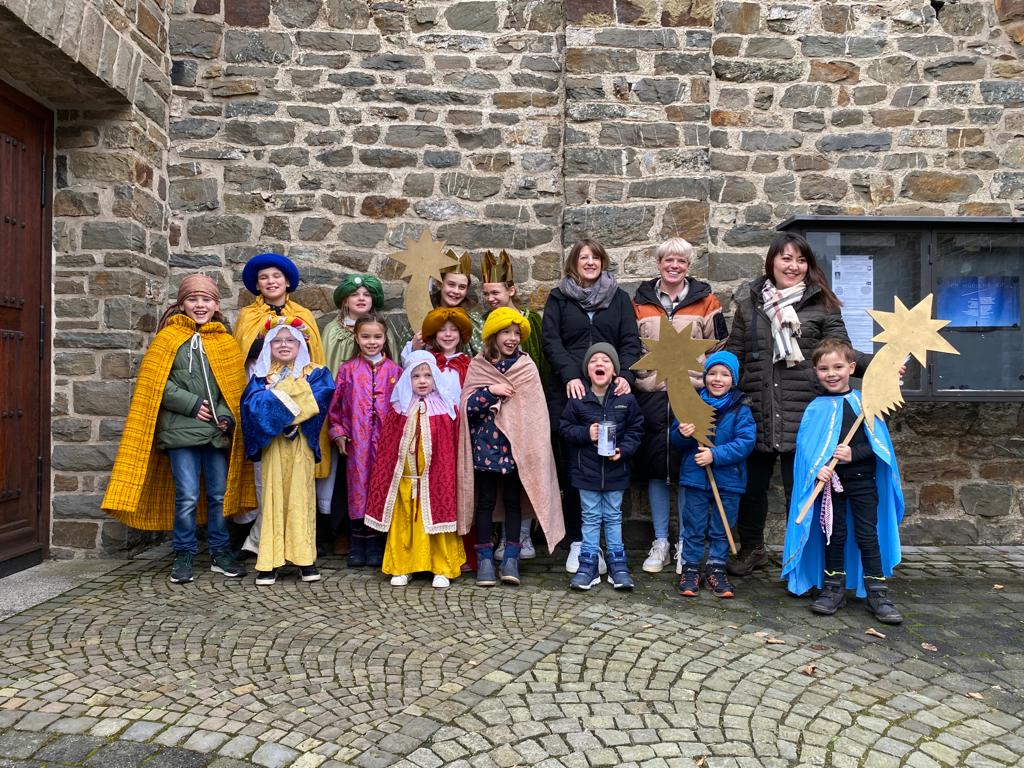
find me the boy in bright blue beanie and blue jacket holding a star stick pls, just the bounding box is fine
[671,351,757,597]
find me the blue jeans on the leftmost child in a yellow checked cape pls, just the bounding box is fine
[167,445,228,555]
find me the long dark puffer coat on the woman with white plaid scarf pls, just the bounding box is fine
[725,275,871,452]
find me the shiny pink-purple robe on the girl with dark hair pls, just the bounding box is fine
[328,355,401,520]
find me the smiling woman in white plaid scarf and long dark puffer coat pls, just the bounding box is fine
[725,232,871,577]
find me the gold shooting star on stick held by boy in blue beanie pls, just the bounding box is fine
[630,314,718,446]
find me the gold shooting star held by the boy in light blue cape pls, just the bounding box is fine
[862,294,959,429]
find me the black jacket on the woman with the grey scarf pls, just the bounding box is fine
[541,288,643,426]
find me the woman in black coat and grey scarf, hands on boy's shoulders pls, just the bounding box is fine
[541,240,642,573]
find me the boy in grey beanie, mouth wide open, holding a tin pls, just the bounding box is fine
[559,342,643,591]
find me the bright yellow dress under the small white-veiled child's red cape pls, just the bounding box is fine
[382,427,466,579]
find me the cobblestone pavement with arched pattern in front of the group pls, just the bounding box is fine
[0,548,1024,768]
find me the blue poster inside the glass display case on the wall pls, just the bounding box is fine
[936,276,1021,329]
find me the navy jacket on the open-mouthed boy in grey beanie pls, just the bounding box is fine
[558,391,643,490]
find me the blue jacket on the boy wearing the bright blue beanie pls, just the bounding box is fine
[672,389,757,494]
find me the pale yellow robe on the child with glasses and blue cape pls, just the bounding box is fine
[256,377,319,570]
